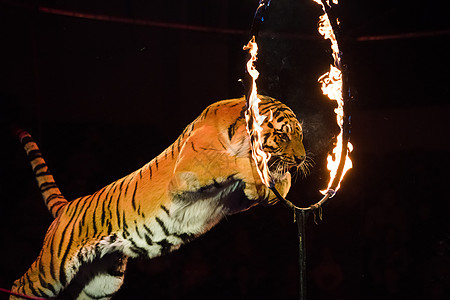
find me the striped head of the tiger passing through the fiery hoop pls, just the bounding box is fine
[259,96,308,181]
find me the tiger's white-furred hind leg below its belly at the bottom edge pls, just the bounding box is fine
[58,252,128,300]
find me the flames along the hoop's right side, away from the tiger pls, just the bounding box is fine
[313,0,353,194]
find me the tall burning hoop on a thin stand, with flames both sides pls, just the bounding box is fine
[244,0,353,300]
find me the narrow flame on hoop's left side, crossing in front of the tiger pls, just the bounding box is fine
[244,36,272,187]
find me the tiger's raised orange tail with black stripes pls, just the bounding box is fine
[14,128,68,218]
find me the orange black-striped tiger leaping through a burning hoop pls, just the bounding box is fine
[10,96,306,299]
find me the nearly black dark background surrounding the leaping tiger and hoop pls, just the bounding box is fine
[0,0,450,299]
